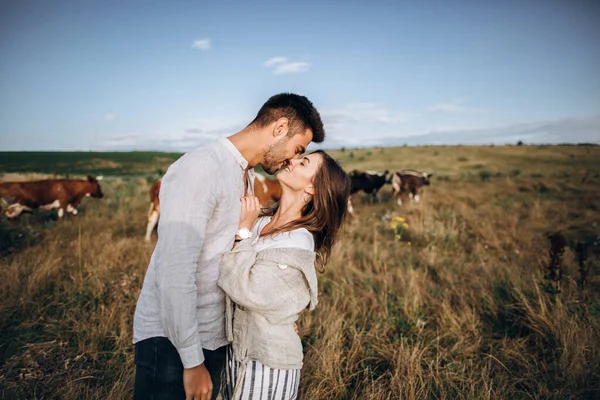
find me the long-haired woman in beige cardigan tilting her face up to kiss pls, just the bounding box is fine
[218,151,350,400]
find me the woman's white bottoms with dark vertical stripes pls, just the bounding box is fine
[221,345,300,400]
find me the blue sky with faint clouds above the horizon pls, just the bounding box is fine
[0,0,600,150]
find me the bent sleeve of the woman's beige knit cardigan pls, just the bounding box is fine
[217,239,300,319]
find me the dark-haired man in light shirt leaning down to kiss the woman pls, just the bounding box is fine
[133,93,325,400]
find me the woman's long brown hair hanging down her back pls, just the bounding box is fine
[262,150,350,272]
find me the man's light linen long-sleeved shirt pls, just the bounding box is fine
[133,138,255,368]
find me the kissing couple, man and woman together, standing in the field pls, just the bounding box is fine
[133,93,350,400]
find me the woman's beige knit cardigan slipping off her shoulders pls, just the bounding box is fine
[218,239,317,399]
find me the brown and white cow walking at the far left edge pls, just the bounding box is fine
[0,176,104,218]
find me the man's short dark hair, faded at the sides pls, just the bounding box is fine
[250,93,325,143]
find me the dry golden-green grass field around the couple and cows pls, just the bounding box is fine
[0,146,600,399]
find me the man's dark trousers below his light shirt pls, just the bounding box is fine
[133,337,227,400]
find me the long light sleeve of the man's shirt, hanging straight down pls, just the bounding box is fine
[155,156,217,368]
